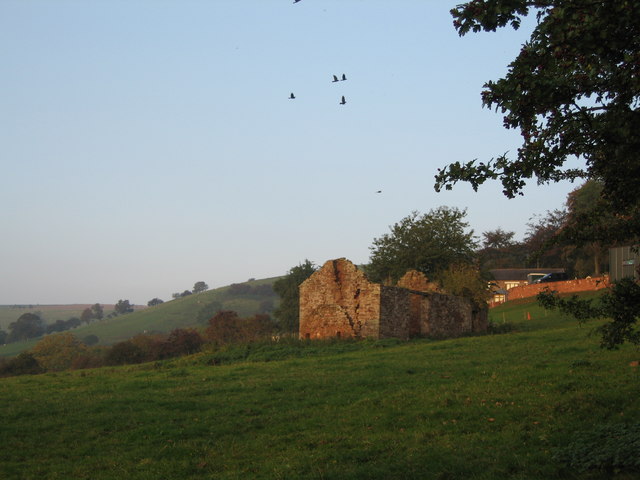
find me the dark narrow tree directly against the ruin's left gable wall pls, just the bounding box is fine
[273,259,317,332]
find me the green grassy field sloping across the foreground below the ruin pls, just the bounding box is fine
[0,304,640,480]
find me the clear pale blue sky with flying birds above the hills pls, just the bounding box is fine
[0,0,577,305]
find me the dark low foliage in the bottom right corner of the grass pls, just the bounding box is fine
[555,423,640,474]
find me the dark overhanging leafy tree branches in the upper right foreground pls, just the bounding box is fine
[435,0,640,236]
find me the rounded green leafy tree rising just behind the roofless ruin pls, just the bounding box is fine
[365,207,476,283]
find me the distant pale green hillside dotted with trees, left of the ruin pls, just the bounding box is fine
[0,277,280,356]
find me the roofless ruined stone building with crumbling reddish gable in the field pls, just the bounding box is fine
[300,258,488,339]
